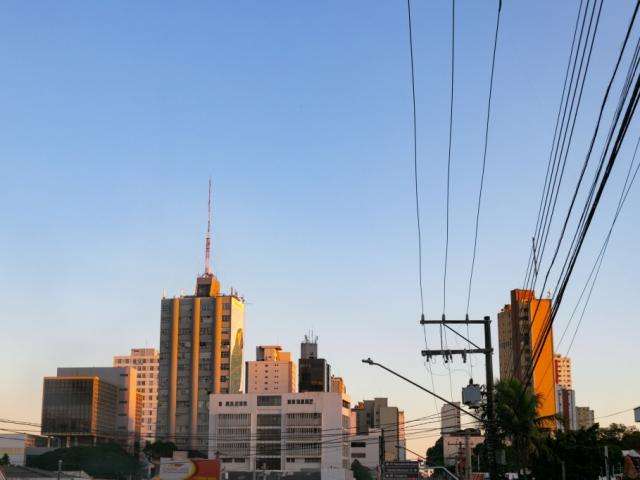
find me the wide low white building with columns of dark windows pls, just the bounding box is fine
[209,392,351,480]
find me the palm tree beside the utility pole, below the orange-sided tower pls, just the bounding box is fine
[495,379,549,477]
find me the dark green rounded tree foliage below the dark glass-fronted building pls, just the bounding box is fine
[29,443,139,479]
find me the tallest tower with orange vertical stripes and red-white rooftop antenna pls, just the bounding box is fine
[156,182,244,452]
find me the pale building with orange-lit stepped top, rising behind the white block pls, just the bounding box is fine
[245,345,298,393]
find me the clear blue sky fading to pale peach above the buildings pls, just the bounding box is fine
[0,0,640,458]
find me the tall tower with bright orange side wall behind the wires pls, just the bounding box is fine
[498,290,556,422]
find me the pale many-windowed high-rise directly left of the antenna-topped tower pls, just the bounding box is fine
[113,348,158,444]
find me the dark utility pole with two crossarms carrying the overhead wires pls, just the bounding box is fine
[420,315,498,480]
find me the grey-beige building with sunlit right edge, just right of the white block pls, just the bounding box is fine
[353,398,406,462]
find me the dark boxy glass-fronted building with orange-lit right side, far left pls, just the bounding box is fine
[41,376,118,447]
